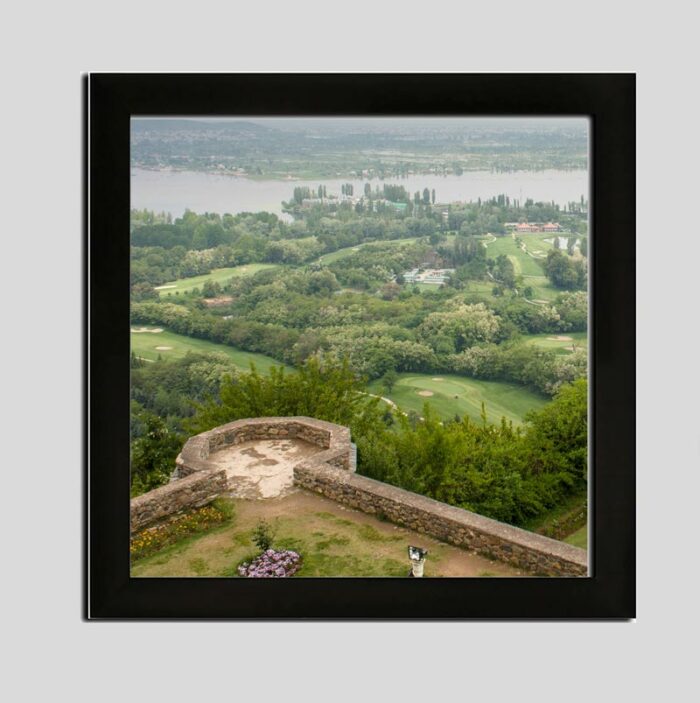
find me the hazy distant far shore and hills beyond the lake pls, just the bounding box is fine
[131,116,588,180]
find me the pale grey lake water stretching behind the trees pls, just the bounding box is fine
[131,168,588,219]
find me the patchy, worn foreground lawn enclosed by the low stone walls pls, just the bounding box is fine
[131,491,527,578]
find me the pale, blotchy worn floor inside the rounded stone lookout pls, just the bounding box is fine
[209,438,323,499]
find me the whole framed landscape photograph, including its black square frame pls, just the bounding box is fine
[85,74,635,620]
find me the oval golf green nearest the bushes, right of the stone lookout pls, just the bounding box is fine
[368,373,548,424]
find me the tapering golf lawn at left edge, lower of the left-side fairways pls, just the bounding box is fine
[131,325,289,373]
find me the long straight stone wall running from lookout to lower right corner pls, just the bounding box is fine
[294,460,588,576]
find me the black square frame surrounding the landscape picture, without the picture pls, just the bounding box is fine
[84,74,635,620]
